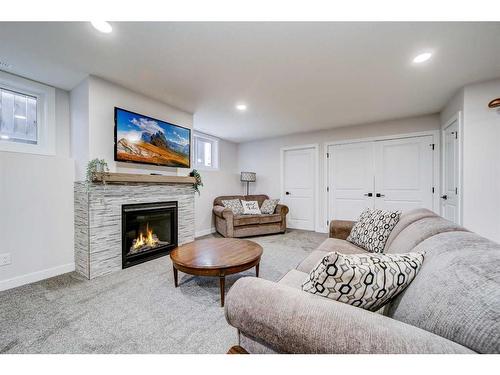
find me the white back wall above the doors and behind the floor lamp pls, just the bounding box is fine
[238,115,440,230]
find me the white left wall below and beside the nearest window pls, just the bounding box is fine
[0,89,74,290]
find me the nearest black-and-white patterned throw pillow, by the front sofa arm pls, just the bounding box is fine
[302,252,424,311]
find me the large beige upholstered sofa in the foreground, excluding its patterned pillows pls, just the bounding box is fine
[225,209,500,353]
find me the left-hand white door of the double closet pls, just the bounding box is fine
[328,142,374,220]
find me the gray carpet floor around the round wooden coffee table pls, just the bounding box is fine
[0,230,326,353]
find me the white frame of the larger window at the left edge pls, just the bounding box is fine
[0,71,56,155]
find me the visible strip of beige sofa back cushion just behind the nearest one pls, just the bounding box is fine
[384,216,466,254]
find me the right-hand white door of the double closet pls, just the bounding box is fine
[374,136,434,211]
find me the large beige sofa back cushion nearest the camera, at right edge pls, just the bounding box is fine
[387,231,500,353]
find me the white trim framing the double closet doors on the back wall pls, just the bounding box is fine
[320,129,441,233]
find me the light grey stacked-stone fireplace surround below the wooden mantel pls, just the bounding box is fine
[74,182,195,279]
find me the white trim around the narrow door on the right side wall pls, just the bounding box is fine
[439,111,464,225]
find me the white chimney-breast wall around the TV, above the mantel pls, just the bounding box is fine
[71,76,193,180]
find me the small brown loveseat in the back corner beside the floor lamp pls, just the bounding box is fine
[213,194,288,237]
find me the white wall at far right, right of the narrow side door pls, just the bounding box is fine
[463,79,500,242]
